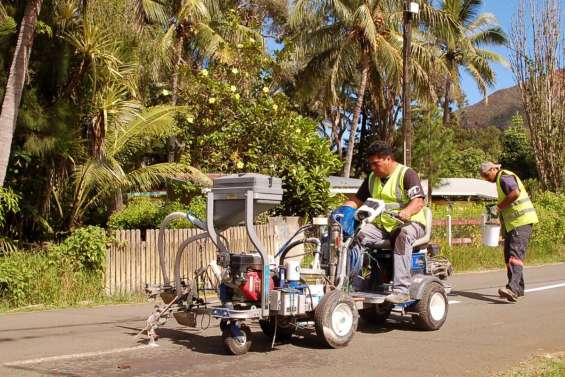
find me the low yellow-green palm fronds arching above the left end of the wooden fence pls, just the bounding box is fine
[67,102,210,228]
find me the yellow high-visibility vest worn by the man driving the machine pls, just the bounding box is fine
[369,164,426,233]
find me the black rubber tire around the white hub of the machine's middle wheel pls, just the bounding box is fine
[314,290,359,348]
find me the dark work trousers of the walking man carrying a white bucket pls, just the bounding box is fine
[504,224,532,296]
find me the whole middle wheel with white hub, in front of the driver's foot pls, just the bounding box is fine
[314,290,359,348]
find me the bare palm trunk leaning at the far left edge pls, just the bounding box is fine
[0,0,43,186]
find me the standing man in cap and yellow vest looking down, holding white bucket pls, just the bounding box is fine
[481,162,538,302]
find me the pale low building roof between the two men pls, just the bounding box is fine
[422,178,498,199]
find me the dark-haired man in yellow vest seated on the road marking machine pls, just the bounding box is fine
[343,142,426,304]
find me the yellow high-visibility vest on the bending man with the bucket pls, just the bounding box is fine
[496,170,538,232]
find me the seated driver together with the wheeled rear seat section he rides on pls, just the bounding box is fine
[334,142,451,330]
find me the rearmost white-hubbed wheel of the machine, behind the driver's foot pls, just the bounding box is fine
[413,282,449,331]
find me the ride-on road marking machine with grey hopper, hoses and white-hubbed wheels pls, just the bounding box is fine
[142,173,449,355]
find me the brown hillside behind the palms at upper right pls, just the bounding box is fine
[459,86,522,128]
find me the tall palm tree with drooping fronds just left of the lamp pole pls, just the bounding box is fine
[291,0,455,177]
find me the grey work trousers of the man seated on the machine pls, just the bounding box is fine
[358,222,425,294]
